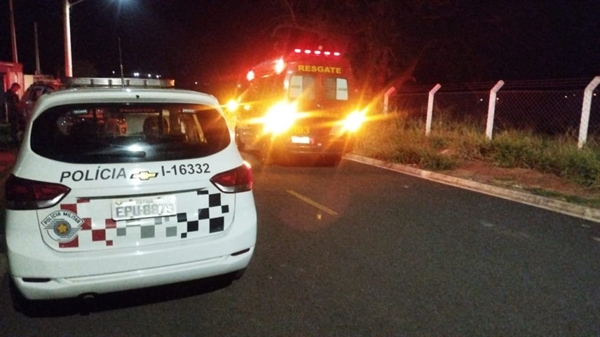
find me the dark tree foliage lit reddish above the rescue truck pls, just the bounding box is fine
[271,0,450,94]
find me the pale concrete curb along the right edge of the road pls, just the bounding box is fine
[344,154,600,223]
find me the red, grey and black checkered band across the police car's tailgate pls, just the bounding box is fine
[42,190,233,249]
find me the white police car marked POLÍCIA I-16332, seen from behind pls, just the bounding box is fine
[5,78,257,308]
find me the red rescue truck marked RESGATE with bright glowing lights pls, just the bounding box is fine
[235,48,366,165]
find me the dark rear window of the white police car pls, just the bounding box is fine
[31,104,230,163]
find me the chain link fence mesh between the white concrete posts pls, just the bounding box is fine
[390,80,600,139]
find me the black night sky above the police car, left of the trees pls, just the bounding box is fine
[0,0,268,90]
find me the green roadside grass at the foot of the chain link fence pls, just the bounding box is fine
[354,114,600,206]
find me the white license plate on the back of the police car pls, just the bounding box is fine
[112,195,177,220]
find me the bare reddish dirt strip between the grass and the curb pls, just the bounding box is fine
[440,161,600,208]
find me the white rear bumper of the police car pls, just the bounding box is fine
[7,192,257,300]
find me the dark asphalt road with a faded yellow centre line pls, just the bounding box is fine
[0,157,600,336]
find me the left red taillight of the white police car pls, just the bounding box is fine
[4,174,71,210]
